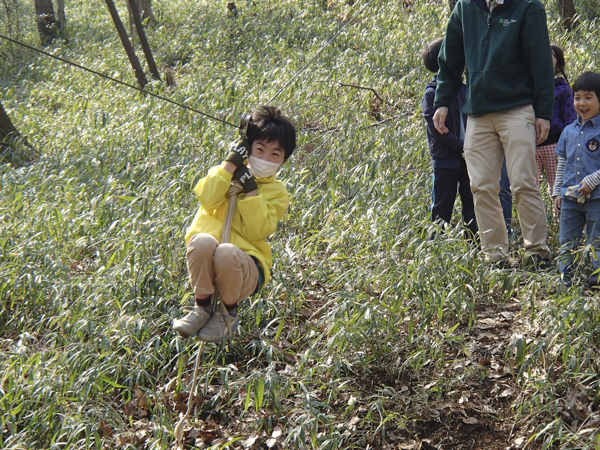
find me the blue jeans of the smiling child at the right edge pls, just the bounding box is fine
[558,198,600,281]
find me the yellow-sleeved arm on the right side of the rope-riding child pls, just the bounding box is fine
[238,181,290,241]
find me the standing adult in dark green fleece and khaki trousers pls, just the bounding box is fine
[433,0,554,265]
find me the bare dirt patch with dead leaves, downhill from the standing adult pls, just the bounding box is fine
[346,299,541,450]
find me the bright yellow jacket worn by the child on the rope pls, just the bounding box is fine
[185,166,290,287]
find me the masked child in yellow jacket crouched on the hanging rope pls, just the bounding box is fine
[173,106,296,342]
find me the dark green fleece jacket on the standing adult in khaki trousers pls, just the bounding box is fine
[434,0,554,120]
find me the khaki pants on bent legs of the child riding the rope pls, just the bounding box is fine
[186,233,258,305]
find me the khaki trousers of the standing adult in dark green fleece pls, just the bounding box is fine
[464,105,551,261]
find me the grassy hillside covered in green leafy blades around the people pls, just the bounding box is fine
[0,0,600,449]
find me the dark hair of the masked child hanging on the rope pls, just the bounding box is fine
[248,105,296,159]
